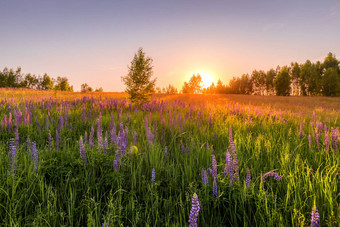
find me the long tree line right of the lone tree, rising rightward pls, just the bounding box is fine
[182,53,340,96]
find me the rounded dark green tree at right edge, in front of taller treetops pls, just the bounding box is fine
[322,68,340,96]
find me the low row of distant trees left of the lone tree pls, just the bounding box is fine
[0,67,73,91]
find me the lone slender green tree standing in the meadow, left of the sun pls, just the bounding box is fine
[122,48,156,105]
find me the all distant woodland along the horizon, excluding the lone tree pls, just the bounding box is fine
[0,53,340,96]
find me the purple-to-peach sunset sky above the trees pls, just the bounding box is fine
[0,0,340,91]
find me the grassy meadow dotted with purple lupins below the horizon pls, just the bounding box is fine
[0,89,340,226]
